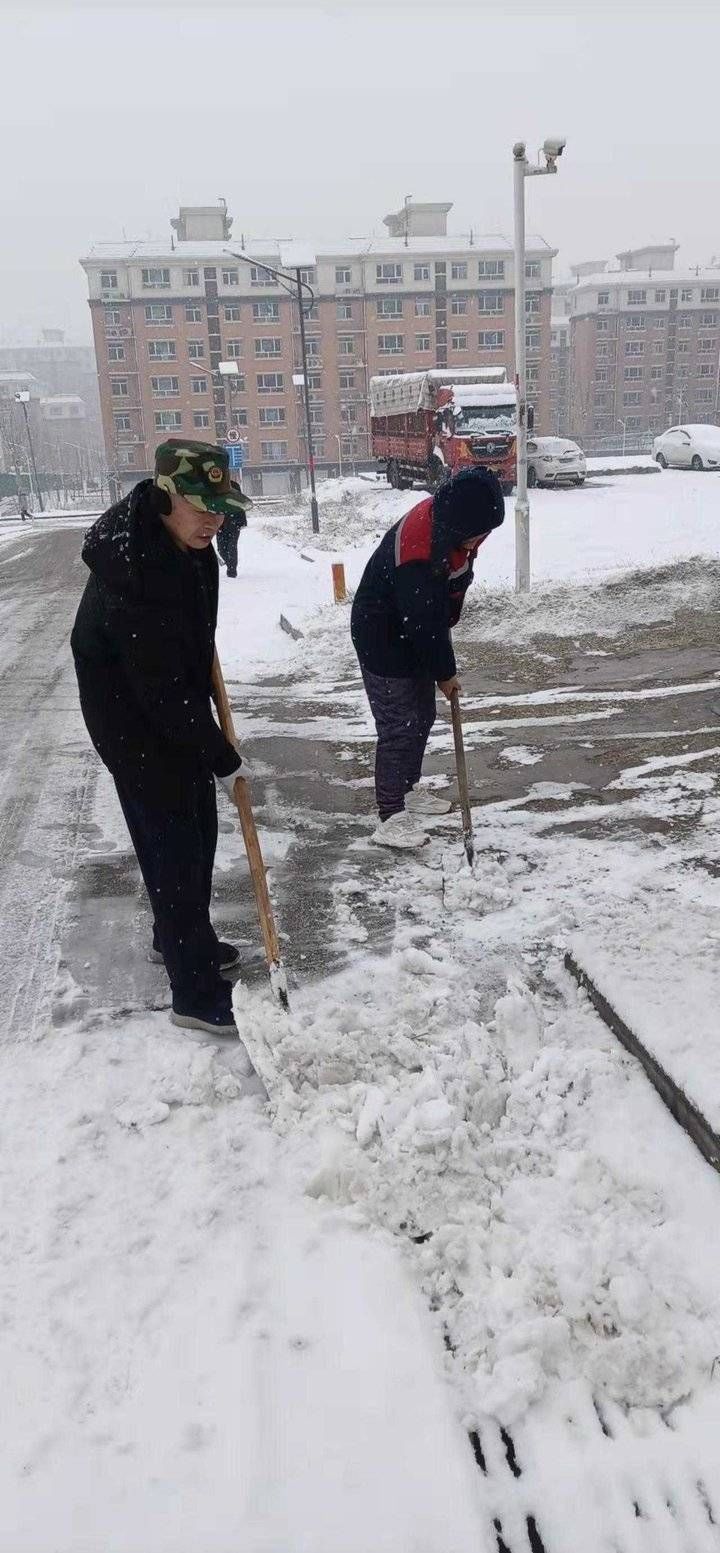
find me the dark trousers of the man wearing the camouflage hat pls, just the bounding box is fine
[113,775,230,1003]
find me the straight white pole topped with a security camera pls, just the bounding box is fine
[512,137,565,593]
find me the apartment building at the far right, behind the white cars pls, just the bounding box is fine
[569,242,720,446]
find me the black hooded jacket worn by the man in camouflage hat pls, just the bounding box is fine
[70,480,239,808]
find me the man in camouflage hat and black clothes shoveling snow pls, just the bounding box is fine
[71,438,250,1034]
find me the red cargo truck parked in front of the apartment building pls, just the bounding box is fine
[369,367,517,492]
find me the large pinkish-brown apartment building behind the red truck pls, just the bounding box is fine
[81,200,554,494]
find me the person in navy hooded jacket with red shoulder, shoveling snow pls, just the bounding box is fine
[351,467,504,848]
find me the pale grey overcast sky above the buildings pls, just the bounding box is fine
[0,0,720,340]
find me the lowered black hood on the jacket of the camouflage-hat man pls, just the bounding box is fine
[82,480,174,596]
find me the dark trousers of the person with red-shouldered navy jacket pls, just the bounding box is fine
[363,669,434,820]
